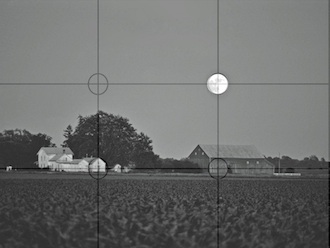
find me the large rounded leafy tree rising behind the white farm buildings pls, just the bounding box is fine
[63,111,158,168]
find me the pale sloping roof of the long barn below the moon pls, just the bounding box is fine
[199,145,264,158]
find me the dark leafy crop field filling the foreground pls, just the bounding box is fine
[0,175,329,248]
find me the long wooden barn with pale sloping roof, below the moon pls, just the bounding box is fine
[188,145,274,174]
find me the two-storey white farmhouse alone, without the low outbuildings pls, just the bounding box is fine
[37,147,73,169]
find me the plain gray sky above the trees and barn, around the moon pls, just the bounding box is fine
[0,0,329,159]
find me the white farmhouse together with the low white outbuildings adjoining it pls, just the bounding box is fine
[37,147,106,172]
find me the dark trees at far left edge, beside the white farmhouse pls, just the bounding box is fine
[0,129,55,168]
